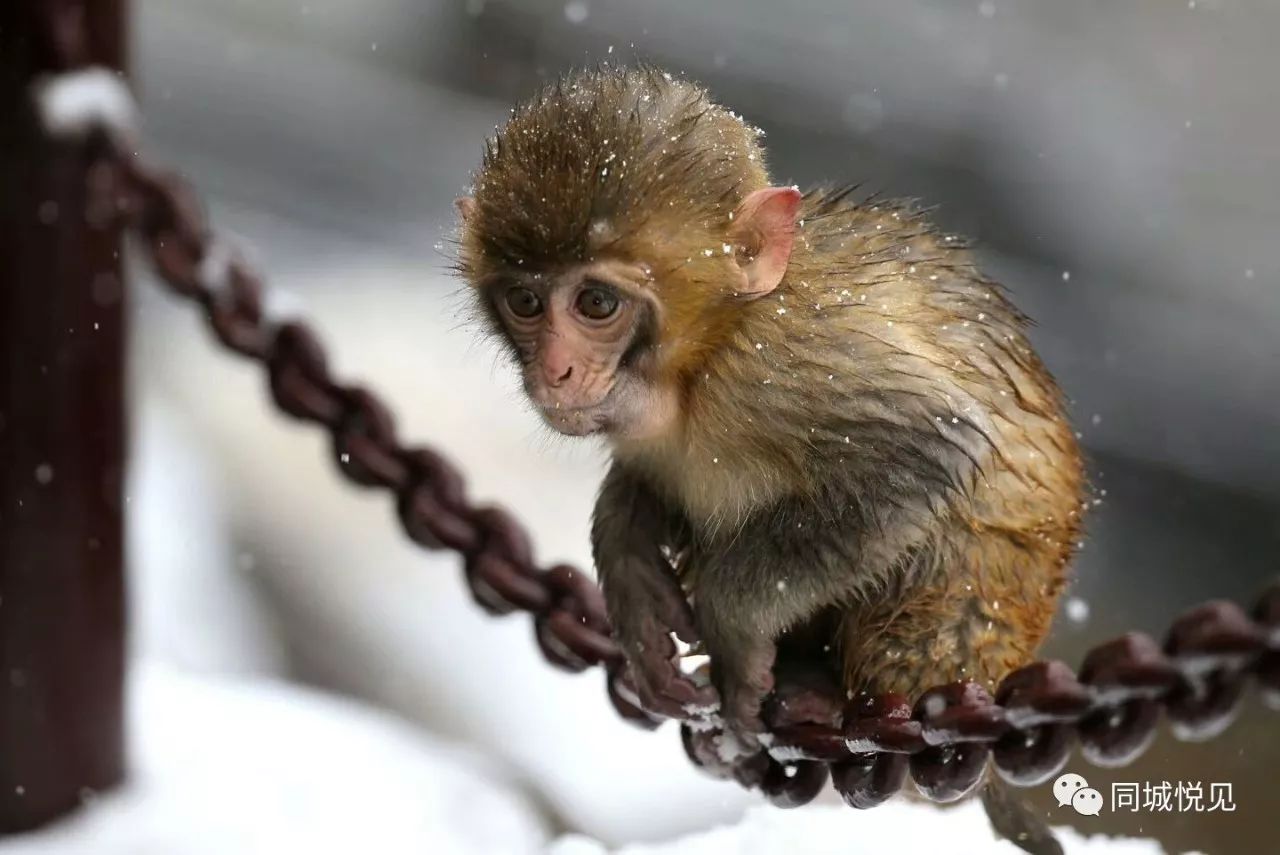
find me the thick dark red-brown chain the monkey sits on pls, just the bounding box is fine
[32,0,1280,808]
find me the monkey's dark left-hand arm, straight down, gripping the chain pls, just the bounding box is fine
[591,463,716,718]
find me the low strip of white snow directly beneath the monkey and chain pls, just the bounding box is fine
[547,800,1164,855]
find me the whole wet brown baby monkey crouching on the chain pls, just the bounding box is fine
[458,68,1083,839]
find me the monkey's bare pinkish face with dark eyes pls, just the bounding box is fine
[483,262,672,436]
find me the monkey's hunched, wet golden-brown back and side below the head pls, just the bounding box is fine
[618,191,1084,692]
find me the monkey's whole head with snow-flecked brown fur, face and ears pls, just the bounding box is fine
[458,68,800,438]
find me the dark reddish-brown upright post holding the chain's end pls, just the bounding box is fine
[0,0,125,835]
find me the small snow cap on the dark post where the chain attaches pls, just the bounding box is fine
[35,68,137,137]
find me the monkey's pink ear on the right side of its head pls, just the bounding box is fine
[730,187,803,298]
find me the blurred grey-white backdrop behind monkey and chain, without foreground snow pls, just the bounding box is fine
[10,0,1280,852]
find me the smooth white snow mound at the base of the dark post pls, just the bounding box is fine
[0,666,548,855]
